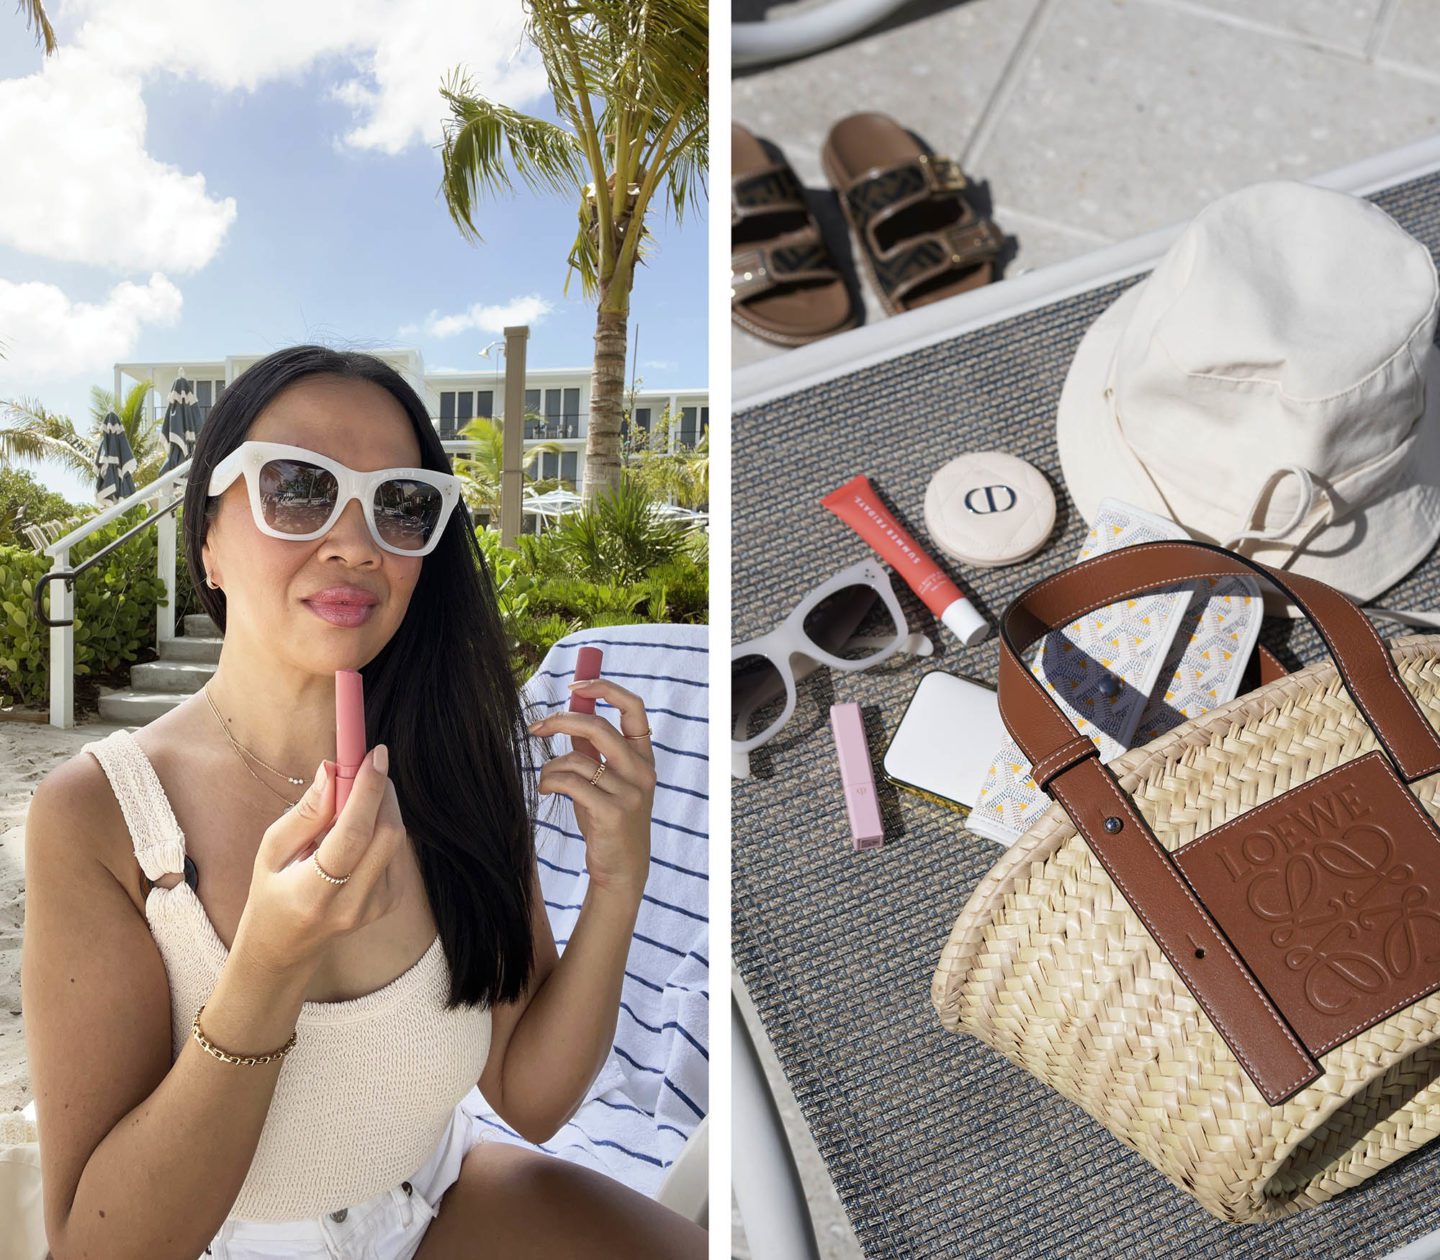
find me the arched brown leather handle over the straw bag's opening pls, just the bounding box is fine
[999,541,1440,788]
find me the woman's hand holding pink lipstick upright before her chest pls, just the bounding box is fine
[233,750,405,975]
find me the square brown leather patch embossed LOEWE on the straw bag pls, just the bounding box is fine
[1175,753,1440,1053]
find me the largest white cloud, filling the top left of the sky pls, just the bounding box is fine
[0,0,546,274]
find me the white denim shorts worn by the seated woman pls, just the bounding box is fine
[203,1100,487,1260]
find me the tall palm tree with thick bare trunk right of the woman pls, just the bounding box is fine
[441,0,710,498]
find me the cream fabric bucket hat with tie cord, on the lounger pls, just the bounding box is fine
[1057,180,1440,600]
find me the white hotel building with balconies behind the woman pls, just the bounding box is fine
[115,348,710,504]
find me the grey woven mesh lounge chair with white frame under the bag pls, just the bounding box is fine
[732,140,1440,1260]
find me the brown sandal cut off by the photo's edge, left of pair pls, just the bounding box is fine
[730,122,855,346]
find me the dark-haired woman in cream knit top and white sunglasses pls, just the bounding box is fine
[22,346,704,1260]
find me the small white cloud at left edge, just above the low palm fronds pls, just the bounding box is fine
[0,272,181,380]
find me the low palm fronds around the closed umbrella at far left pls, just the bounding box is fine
[0,382,168,490]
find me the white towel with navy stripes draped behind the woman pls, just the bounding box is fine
[469,625,710,1195]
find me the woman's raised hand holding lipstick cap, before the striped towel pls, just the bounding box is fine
[530,678,655,904]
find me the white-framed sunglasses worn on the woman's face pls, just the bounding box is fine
[207,442,459,556]
